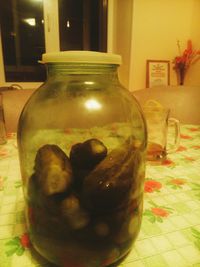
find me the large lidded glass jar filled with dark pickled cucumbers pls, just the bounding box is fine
[18,51,146,267]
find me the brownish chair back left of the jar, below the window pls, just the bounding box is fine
[0,89,35,133]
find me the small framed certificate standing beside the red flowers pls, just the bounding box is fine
[146,60,170,88]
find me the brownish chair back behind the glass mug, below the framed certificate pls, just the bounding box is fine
[133,86,200,124]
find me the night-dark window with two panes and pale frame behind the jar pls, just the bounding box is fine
[0,0,108,83]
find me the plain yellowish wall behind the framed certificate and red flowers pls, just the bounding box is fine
[129,0,200,91]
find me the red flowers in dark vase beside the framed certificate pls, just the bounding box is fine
[173,40,200,85]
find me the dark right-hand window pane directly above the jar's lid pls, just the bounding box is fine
[59,0,108,51]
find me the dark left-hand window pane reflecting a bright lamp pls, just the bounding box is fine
[0,0,45,82]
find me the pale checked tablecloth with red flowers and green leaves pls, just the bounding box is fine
[0,125,200,267]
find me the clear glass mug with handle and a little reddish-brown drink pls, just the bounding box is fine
[143,100,180,162]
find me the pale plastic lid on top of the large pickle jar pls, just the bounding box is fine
[42,51,121,65]
